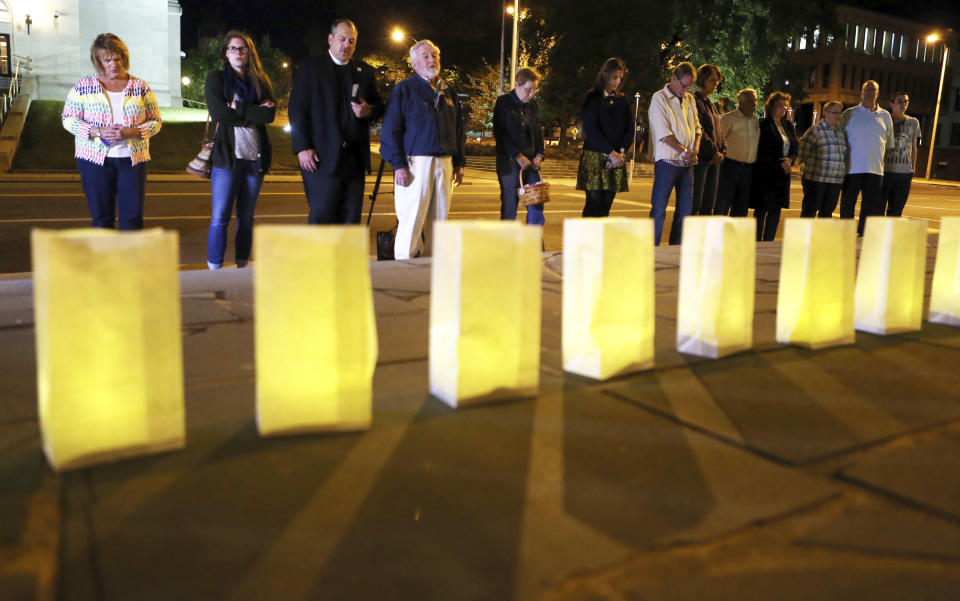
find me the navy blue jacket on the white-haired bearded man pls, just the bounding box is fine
[380,74,467,169]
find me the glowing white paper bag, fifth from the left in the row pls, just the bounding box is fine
[677,216,757,359]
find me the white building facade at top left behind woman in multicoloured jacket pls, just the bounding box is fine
[0,0,182,106]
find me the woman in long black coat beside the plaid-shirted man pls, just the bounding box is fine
[750,92,797,242]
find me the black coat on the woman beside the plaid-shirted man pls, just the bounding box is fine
[750,117,797,209]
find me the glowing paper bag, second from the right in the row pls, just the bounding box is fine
[854,217,927,334]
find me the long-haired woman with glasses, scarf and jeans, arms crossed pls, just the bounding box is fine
[204,31,276,269]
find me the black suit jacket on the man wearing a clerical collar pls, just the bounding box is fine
[288,52,384,175]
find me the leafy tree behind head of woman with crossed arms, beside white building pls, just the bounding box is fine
[180,32,293,109]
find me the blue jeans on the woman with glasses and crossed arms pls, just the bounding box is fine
[207,159,263,269]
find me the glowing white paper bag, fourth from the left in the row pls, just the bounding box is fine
[562,218,655,380]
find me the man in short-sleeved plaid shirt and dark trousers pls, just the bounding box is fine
[798,100,847,217]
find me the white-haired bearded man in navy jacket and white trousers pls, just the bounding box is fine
[380,40,466,259]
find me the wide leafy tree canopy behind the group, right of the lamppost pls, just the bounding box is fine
[521,0,835,145]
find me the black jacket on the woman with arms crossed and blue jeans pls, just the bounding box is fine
[203,69,277,173]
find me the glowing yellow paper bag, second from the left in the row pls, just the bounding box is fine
[254,225,378,435]
